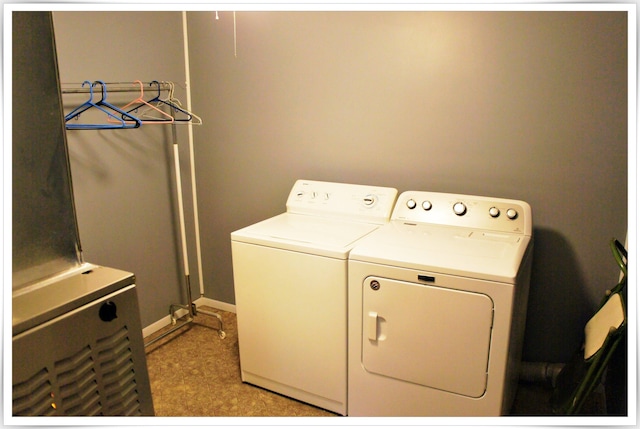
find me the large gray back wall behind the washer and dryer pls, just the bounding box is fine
[188,12,627,361]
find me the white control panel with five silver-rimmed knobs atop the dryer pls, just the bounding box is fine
[391,191,532,236]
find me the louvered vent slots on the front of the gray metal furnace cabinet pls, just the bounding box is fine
[13,326,142,416]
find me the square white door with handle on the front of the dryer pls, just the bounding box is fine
[362,277,493,398]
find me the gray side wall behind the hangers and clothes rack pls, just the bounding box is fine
[53,12,199,326]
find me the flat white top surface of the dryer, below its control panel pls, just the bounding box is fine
[350,221,532,283]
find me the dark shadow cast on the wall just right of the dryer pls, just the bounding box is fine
[522,228,593,362]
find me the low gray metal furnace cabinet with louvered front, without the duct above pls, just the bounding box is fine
[12,265,154,416]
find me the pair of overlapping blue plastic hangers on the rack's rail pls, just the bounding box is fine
[64,80,142,130]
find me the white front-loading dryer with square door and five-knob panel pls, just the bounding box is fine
[348,191,533,416]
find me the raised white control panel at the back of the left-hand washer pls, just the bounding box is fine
[287,180,398,225]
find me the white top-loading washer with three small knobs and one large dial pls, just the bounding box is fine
[231,180,397,415]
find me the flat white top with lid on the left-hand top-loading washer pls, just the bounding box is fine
[231,213,380,259]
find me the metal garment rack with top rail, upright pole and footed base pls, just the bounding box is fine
[61,81,226,347]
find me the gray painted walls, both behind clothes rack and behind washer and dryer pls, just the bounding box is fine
[54,12,627,361]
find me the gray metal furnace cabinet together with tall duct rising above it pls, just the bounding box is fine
[11,11,154,418]
